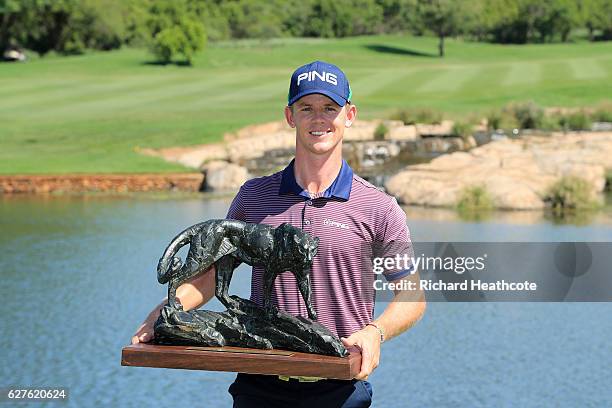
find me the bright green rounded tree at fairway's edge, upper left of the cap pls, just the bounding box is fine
[148,0,206,65]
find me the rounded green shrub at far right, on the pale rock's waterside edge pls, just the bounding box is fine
[544,176,597,211]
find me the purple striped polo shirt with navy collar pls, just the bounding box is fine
[227,161,412,337]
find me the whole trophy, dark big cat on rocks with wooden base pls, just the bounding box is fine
[122,219,361,379]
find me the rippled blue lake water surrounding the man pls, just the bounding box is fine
[0,195,612,407]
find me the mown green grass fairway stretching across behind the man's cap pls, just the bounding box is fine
[0,36,612,174]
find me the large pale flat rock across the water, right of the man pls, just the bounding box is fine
[385,132,612,210]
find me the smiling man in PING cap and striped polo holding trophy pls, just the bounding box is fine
[132,61,425,407]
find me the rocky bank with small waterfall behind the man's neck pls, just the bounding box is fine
[139,120,476,191]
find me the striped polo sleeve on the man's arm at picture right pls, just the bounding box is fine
[375,198,415,282]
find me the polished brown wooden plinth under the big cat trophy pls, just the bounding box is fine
[121,343,361,380]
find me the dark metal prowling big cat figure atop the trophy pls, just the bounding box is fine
[157,220,319,320]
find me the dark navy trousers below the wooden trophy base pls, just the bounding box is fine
[229,374,372,408]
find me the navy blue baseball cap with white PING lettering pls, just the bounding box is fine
[287,61,352,106]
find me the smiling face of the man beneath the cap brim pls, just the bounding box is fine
[285,94,357,155]
